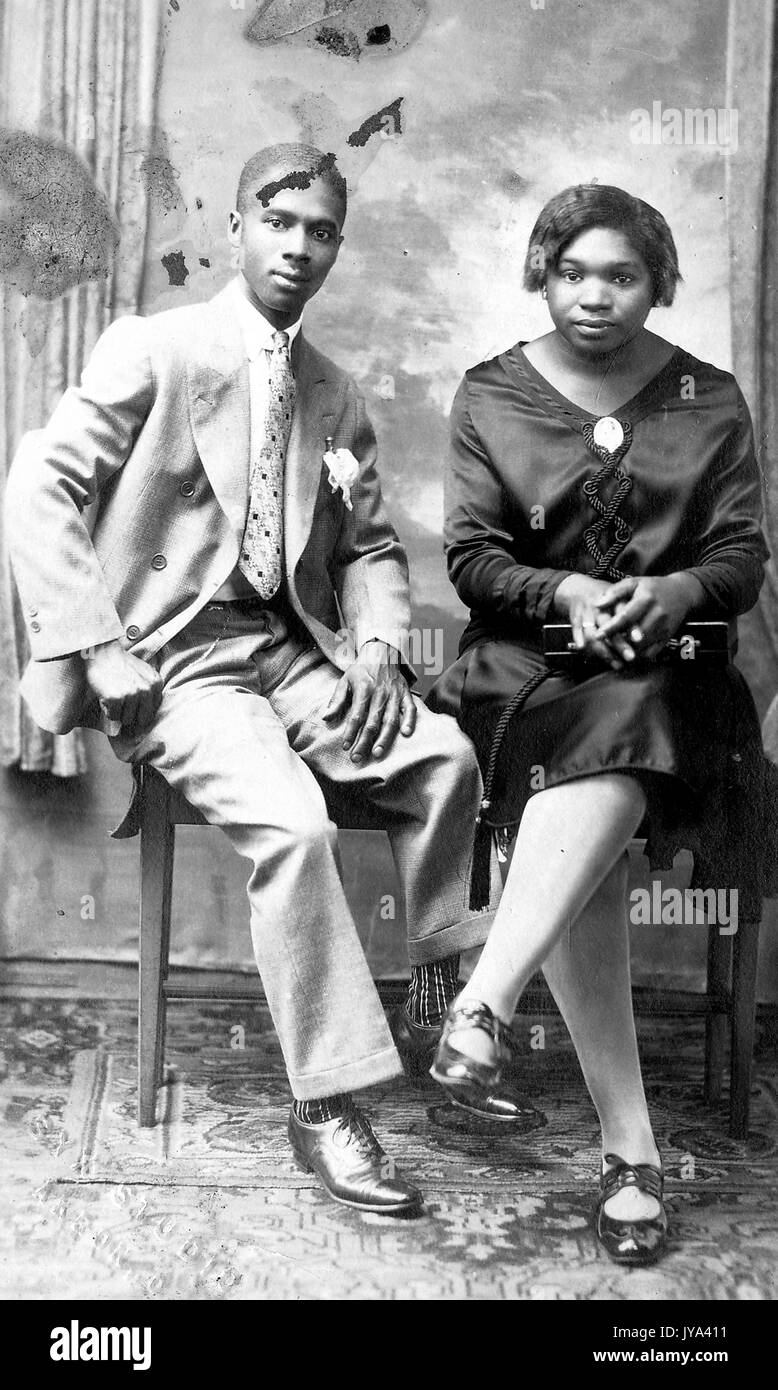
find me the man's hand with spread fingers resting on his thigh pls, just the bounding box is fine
[324,641,415,763]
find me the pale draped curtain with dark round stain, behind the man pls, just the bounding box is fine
[0,0,164,776]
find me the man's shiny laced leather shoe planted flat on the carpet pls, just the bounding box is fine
[289,1105,422,1215]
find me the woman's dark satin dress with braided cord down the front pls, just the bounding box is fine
[429,345,777,917]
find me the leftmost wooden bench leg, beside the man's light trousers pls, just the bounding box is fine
[138,777,175,1127]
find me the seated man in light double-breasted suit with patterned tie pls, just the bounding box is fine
[7,146,530,1212]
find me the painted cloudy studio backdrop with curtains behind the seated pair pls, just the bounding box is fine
[0,0,778,998]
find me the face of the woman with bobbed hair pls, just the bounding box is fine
[546,227,654,357]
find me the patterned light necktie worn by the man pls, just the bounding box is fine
[238,332,295,599]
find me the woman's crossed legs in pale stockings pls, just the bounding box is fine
[453,773,659,1220]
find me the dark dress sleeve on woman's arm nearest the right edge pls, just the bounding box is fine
[686,389,770,619]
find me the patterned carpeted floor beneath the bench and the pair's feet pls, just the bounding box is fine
[0,988,778,1301]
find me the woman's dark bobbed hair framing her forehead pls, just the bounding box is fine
[524,183,681,307]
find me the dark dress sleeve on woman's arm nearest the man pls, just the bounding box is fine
[445,377,572,626]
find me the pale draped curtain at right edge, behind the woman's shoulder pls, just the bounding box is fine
[727,0,778,709]
